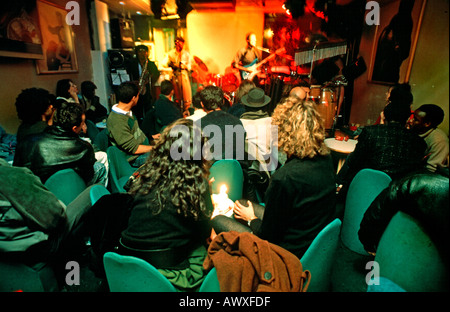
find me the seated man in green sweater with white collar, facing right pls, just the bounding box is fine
[106,82,152,167]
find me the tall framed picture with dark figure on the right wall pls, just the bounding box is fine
[368,0,427,85]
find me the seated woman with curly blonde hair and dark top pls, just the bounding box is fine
[212,97,336,258]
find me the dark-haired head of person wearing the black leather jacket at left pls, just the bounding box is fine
[54,101,87,134]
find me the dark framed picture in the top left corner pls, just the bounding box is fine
[0,0,43,59]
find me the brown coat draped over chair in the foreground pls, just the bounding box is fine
[203,231,310,292]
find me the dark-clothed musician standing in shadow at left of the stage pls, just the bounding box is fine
[127,45,160,124]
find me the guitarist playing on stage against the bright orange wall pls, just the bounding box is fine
[231,33,261,84]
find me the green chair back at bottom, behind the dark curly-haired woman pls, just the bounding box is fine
[103,252,177,292]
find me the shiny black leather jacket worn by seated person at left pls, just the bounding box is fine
[14,126,95,183]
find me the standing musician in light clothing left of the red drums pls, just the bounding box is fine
[163,37,192,114]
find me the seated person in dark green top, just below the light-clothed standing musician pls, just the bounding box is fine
[155,80,183,127]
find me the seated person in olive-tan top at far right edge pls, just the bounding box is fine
[408,104,449,172]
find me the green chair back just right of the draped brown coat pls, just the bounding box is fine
[300,219,342,292]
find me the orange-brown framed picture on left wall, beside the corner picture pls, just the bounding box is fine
[36,0,78,74]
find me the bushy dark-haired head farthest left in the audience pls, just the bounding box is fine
[15,88,55,124]
